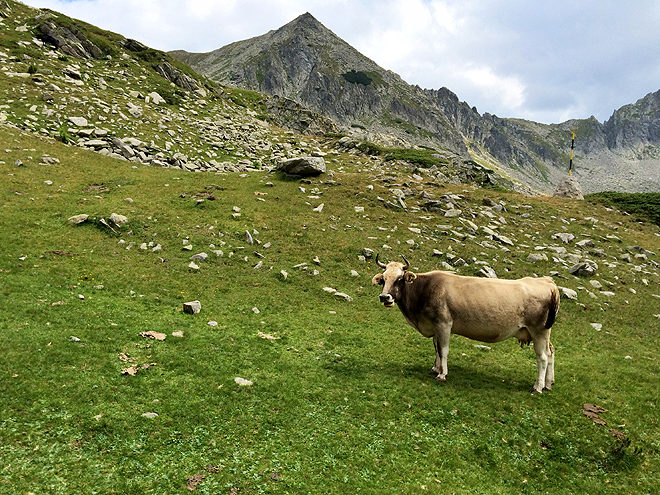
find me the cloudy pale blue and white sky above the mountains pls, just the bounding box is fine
[24,0,660,123]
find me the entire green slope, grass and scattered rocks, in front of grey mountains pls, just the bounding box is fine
[0,0,660,495]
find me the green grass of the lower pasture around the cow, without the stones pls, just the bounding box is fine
[0,127,660,494]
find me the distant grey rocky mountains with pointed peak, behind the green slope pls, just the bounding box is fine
[171,13,660,192]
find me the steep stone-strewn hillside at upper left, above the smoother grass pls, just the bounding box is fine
[0,1,505,192]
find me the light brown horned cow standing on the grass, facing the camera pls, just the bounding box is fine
[372,255,559,394]
